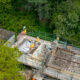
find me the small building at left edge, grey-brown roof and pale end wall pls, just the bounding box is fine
[0,29,15,46]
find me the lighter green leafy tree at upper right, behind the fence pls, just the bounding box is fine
[51,1,80,44]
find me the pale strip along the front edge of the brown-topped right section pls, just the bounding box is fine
[43,67,80,80]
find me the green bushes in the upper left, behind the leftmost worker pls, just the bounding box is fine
[0,0,39,33]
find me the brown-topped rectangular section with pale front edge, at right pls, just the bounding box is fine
[44,47,80,80]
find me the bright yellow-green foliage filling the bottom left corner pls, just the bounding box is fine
[0,44,25,80]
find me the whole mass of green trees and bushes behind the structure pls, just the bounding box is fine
[0,0,80,45]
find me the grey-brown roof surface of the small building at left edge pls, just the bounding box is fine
[0,28,15,41]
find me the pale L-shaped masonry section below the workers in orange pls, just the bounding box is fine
[18,44,46,69]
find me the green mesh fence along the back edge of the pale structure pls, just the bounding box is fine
[27,30,80,48]
